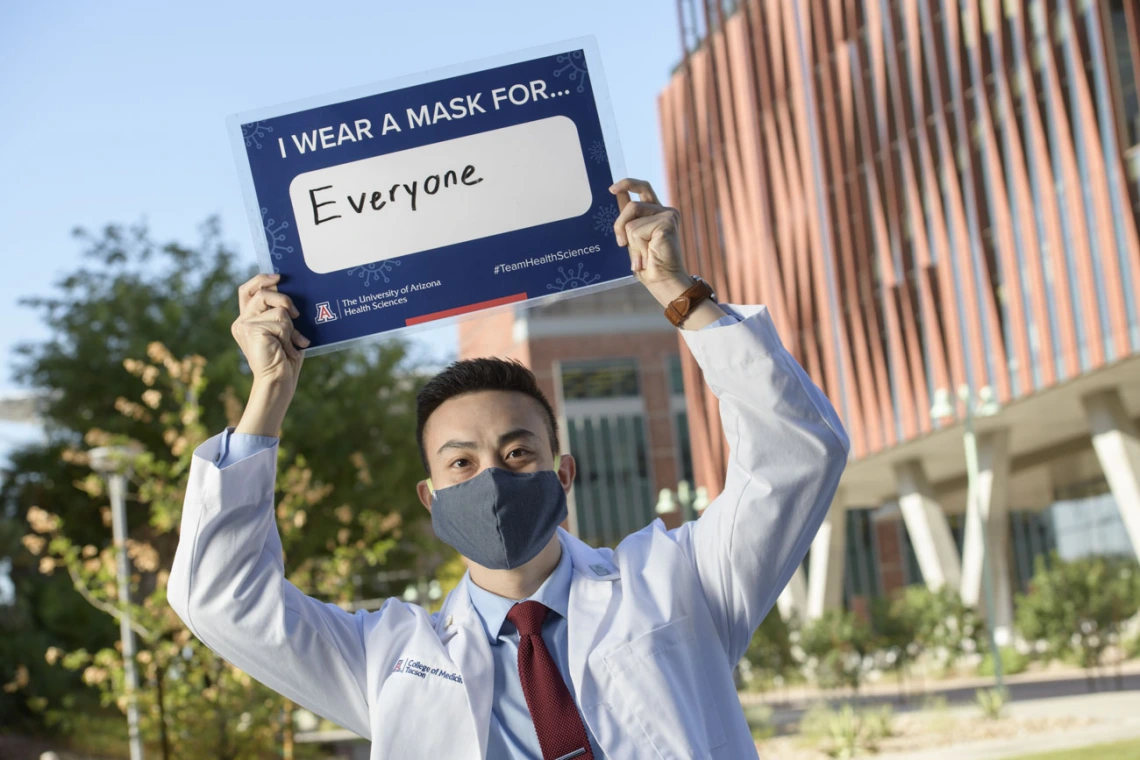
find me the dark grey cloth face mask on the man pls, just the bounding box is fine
[429,467,568,570]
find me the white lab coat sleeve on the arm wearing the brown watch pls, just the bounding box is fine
[675,307,849,662]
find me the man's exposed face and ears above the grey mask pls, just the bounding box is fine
[417,391,575,510]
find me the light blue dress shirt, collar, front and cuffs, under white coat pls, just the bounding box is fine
[214,304,741,760]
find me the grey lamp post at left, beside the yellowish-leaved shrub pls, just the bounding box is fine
[88,446,143,760]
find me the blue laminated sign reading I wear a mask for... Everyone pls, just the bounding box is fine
[230,39,630,353]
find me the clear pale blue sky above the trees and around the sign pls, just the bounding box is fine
[0,0,679,410]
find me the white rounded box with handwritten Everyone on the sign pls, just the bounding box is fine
[290,116,593,273]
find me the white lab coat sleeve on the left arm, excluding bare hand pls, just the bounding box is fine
[168,435,369,738]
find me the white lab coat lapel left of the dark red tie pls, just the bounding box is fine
[437,575,495,758]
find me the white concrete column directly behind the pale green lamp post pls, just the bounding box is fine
[961,430,1013,645]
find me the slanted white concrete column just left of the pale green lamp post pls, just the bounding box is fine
[895,459,962,589]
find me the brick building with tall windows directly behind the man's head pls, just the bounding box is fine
[458,287,693,546]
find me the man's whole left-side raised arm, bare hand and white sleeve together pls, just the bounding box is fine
[168,275,368,737]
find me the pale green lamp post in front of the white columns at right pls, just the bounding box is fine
[930,385,1003,689]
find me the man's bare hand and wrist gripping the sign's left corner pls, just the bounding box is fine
[230,275,309,436]
